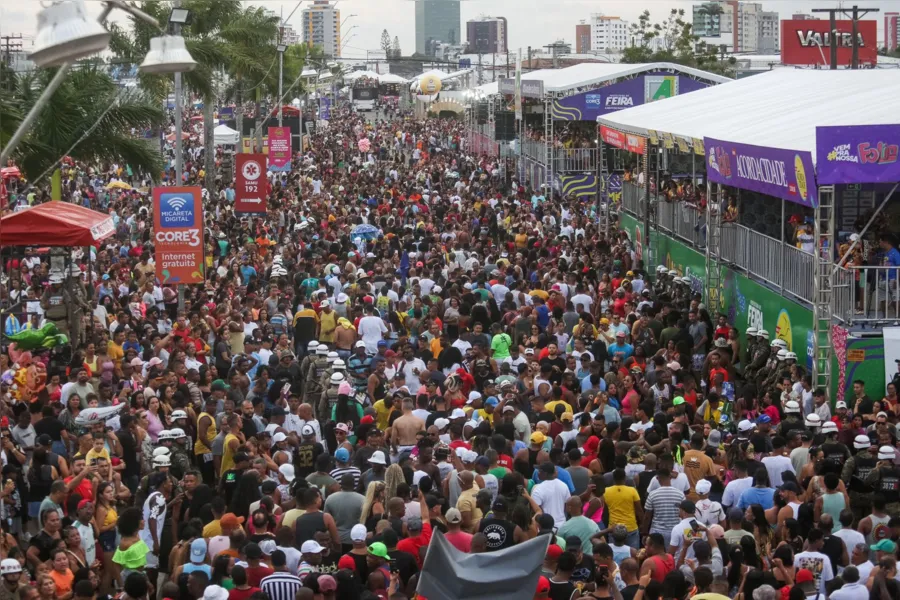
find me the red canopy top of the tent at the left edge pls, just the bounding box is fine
[0,202,116,246]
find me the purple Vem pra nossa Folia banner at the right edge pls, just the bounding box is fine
[816,125,900,185]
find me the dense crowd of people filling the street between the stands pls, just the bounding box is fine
[0,96,900,600]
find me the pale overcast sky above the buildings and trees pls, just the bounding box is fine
[0,0,900,57]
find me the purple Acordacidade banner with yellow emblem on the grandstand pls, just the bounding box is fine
[703,138,819,207]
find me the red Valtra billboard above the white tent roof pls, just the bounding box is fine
[781,19,878,67]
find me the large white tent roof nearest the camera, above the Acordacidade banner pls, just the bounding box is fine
[598,69,900,160]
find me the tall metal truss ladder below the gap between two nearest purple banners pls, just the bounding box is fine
[812,185,835,399]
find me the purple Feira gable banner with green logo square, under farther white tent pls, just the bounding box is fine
[553,73,709,121]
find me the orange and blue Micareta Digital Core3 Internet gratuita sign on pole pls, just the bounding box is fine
[153,187,204,283]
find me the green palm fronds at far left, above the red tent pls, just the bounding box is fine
[0,61,165,180]
